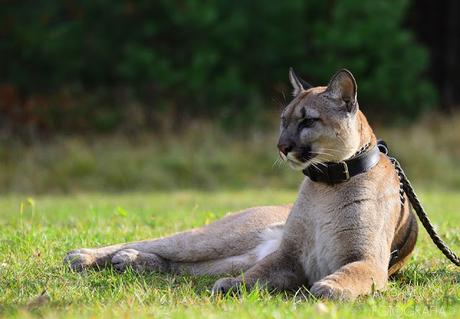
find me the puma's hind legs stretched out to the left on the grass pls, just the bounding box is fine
[65,206,290,273]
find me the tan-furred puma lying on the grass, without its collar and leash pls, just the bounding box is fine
[65,71,417,299]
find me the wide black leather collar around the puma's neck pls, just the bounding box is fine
[303,145,380,185]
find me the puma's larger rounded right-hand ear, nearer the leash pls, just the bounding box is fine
[327,69,358,112]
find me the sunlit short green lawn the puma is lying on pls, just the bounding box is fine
[0,189,460,319]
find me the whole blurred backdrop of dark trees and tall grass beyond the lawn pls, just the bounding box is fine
[0,0,460,193]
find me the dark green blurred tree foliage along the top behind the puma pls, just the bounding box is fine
[0,0,434,131]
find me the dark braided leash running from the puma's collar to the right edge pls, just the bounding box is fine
[378,141,460,267]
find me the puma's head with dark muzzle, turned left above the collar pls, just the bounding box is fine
[278,68,375,169]
